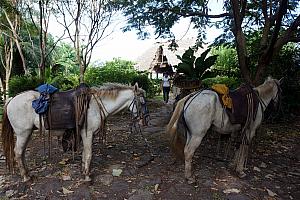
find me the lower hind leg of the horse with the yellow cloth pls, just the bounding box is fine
[184,133,205,184]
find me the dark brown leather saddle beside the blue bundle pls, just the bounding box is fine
[44,84,90,130]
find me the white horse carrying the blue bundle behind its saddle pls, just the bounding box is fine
[1,84,146,181]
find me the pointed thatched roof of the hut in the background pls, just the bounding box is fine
[135,38,207,71]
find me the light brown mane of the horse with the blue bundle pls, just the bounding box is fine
[91,83,144,99]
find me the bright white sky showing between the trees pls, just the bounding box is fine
[49,0,223,62]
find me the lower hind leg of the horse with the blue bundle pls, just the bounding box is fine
[14,130,32,182]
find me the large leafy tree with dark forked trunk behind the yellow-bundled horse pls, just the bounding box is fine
[119,0,300,85]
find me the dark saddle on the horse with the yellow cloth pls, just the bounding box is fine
[215,84,259,127]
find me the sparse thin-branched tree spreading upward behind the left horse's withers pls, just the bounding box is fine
[56,0,119,82]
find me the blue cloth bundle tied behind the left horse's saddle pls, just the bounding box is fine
[32,84,58,114]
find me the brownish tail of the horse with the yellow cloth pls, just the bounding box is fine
[166,95,189,158]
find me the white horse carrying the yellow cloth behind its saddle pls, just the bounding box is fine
[167,77,281,183]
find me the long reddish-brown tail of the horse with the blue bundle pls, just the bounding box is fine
[1,99,15,171]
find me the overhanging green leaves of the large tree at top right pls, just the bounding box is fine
[119,0,299,43]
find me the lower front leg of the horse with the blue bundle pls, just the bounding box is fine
[81,130,93,182]
